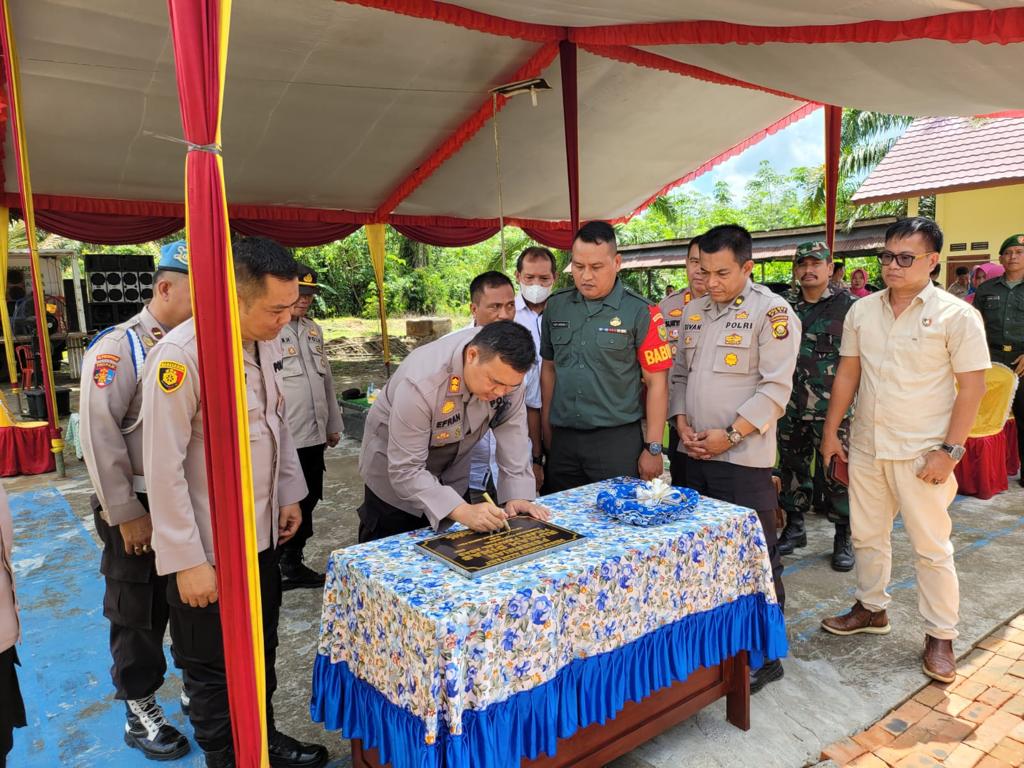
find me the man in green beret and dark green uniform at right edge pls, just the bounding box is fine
[974,233,1024,485]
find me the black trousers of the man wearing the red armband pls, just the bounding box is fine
[544,421,643,494]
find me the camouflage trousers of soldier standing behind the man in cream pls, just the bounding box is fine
[778,413,850,522]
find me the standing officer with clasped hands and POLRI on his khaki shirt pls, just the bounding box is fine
[669,224,801,692]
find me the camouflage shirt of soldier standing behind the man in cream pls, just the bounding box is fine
[785,288,855,420]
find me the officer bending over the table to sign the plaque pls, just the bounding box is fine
[358,321,548,542]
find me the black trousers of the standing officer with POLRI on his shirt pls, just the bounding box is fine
[686,456,785,610]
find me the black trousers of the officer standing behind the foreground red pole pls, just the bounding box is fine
[167,549,281,752]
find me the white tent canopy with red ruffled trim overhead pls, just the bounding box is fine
[4,0,1024,240]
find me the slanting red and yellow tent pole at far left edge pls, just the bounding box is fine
[0,0,65,477]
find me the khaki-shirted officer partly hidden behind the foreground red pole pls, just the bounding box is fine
[142,238,328,768]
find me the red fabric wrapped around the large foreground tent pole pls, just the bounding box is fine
[168,0,264,768]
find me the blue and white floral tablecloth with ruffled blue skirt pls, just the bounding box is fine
[310,478,786,768]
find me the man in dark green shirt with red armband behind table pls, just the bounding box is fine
[541,221,672,493]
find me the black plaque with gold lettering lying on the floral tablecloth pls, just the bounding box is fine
[416,517,584,579]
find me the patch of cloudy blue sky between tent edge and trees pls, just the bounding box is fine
[679,110,825,201]
